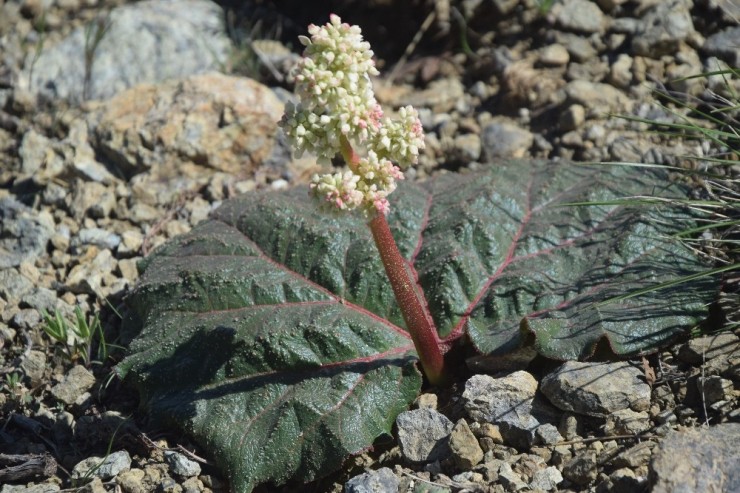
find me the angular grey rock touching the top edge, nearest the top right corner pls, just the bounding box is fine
[632,0,696,58]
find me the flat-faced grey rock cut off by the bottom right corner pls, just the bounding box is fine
[650,423,740,493]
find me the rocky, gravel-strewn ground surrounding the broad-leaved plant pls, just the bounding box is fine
[0,0,740,493]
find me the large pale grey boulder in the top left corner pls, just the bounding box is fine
[19,0,230,101]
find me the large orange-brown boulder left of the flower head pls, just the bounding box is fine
[90,73,283,178]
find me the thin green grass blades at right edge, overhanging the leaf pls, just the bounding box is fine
[580,68,740,330]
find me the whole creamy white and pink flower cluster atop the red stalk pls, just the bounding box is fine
[280,14,424,214]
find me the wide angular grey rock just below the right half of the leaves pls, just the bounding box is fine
[540,361,650,417]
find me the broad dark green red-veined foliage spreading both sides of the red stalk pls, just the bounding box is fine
[118,161,712,491]
